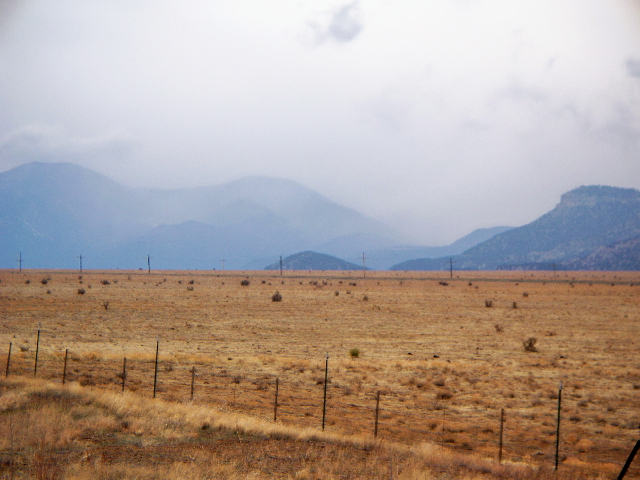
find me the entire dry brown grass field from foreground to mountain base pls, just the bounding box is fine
[0,270,640,479]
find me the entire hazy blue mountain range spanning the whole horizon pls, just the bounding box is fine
[0,162,640,270]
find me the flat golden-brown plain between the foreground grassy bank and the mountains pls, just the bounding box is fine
[0,271,640,478]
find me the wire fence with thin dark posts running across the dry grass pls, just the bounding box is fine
[5,341,640,479]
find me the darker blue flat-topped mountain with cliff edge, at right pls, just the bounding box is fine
[391,186,640,270]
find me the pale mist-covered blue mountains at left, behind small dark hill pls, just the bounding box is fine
[0,162,500,269]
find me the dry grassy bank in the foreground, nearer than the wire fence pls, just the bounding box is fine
[0,378,577,480]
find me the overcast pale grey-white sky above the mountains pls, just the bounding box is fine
[0,0,640,245]
